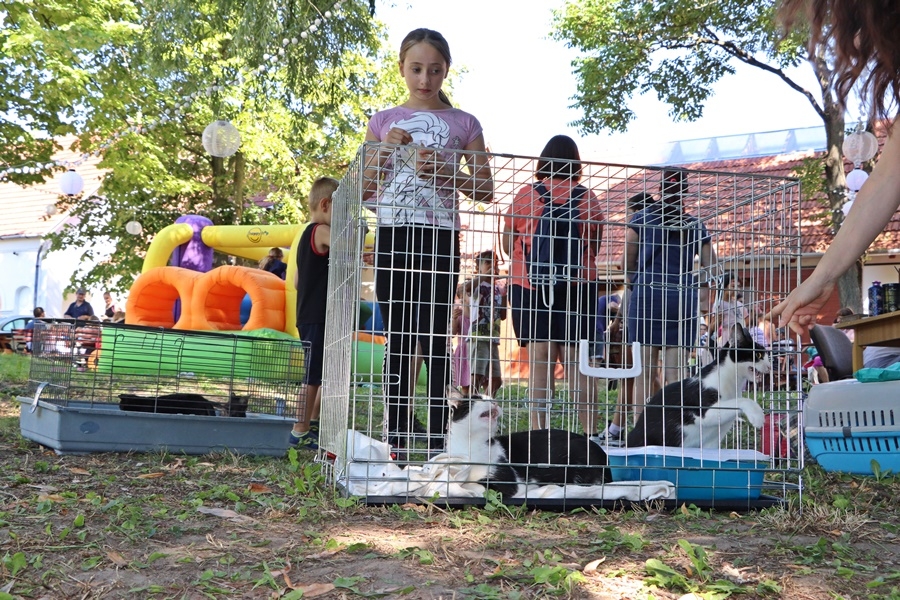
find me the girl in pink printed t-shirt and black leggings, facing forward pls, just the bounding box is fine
[363,29,493,449]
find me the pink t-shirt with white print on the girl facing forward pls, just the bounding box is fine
[369,106,482,229]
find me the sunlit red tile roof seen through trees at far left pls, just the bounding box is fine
[0,136,105,239]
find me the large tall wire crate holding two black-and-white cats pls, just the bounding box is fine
[319,144,804,508]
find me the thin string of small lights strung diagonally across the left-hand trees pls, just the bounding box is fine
[0,0,344,181]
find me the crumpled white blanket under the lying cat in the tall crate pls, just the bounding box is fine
[337,430,675,501]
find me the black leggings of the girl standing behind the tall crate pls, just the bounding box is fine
[375,226,459,435]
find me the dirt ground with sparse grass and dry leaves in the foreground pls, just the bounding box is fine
[0,384,900,600]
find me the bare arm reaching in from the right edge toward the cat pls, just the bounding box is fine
[771,124,900,334]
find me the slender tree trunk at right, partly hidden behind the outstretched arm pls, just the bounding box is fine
[814,51,862,313]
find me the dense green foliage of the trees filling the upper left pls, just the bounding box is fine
[0,0,402,289]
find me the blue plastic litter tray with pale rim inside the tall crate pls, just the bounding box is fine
[606,446,771,502]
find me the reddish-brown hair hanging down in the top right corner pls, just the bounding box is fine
[778,0,900,123]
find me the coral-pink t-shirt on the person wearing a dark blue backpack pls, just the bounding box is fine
[503,179,603,288]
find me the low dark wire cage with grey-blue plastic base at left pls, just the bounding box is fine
[19,320,305,456]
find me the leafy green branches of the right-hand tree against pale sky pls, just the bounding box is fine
[553,0,806,133]
